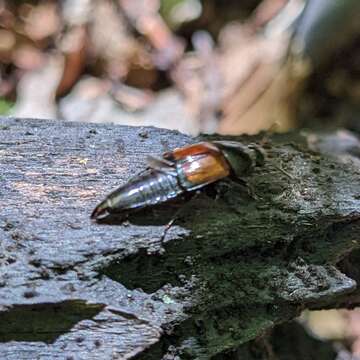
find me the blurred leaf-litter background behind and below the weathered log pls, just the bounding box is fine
[0,0,360,359]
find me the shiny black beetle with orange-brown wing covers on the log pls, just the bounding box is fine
[91,141,264,220]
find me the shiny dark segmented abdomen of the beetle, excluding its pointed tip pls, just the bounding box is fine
[108,170,184,212]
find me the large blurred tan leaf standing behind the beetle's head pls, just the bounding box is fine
[218,0,306,134]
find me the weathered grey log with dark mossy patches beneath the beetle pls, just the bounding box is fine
[0,118,360,360]
